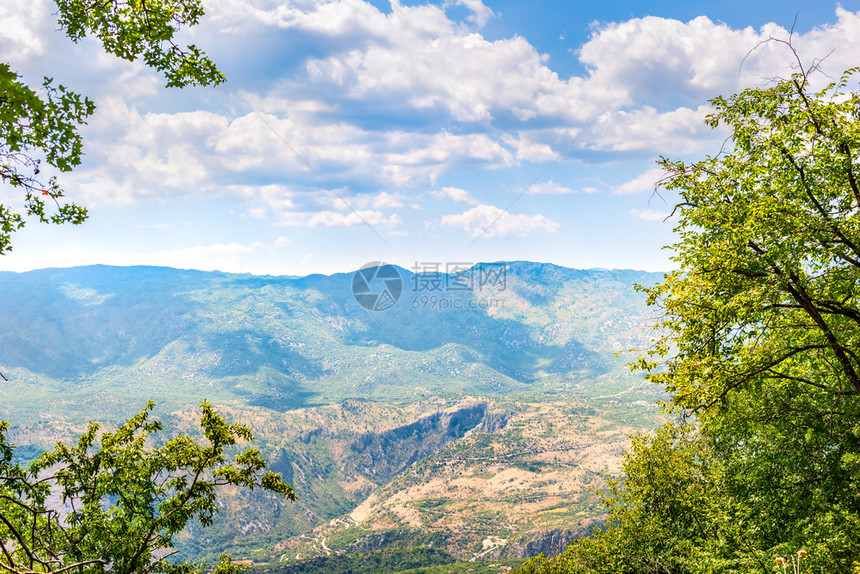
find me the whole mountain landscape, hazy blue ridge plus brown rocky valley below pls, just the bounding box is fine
[0,262,661,562]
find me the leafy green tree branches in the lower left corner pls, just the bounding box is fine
[0,401,295,574]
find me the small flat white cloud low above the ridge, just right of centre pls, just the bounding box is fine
[440,204,561,238]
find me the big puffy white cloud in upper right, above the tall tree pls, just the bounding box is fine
[579,7,860,107]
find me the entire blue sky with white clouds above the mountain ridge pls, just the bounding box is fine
[0,0,860,275]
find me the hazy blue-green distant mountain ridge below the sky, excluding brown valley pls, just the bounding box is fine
[0,262,658,413]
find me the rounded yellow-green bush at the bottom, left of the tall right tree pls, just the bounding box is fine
[521,424,736,574]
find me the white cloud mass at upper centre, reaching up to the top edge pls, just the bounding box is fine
[267,0,594,122]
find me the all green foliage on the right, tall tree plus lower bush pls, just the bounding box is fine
[516,65,860,573]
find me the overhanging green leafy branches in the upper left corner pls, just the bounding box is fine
[0,0,225,255]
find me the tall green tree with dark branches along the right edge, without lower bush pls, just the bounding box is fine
[640,62,860,572]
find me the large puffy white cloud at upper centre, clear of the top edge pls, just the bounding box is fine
[307,26,595,122]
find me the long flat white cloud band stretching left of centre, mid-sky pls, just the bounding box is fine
[67,102,515,209]
